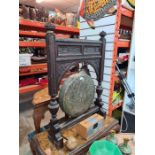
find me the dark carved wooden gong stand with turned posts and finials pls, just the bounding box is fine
[45,24,106,148]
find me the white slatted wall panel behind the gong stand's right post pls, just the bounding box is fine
[80,15,116,111]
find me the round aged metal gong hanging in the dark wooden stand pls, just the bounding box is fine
[59,71,95,117]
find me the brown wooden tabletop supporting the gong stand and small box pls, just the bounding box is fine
[30,116,120,155]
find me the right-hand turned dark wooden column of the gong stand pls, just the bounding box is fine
[95,31,106,117]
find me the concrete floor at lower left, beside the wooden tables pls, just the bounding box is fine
[19,92,50,155]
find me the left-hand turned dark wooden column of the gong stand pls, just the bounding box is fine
[45,24,63,148]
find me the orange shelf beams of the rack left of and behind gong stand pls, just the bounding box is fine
[19,19,79,94]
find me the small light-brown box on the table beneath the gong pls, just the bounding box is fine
[76,114,104,139]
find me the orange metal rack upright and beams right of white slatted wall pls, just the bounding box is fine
[108,0,134,116]
